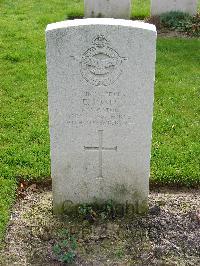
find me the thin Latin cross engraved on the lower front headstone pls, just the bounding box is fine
[84,130,117,178]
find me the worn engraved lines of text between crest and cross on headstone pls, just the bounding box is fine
[67,90,132,127]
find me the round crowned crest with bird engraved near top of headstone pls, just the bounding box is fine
[80,35,127,86]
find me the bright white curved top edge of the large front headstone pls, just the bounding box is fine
[46,18,156,33]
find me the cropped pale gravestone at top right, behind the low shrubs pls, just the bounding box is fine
[151,0,197,16]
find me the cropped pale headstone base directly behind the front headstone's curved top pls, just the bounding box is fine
[84,0,131,19]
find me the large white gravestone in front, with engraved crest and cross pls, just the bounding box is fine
[46,19,156,212]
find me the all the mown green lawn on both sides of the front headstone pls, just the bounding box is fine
[0,0,200,242]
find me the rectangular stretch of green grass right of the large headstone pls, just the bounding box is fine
[151,39,200,185]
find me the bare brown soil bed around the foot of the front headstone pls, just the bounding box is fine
[0,189,200,266]
